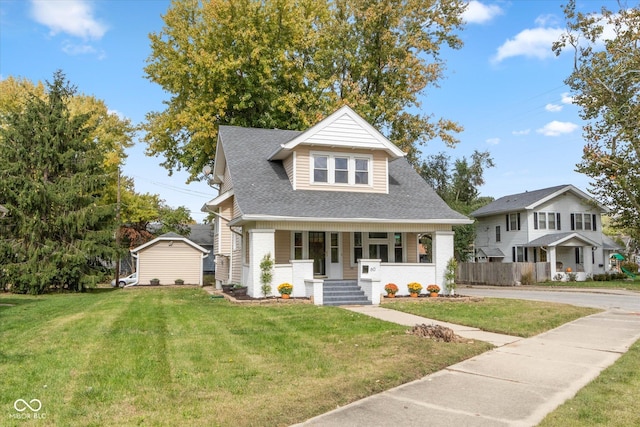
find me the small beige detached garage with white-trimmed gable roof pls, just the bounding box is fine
[131,233,209,286]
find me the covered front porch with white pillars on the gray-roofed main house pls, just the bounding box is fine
[232,224,453,305]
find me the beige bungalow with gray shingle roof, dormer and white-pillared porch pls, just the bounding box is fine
[202,106,471,305]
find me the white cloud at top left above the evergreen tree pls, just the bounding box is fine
[31,0,107,40]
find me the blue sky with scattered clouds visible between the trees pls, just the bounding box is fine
[0,0,636,222]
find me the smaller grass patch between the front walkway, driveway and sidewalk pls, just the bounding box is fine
[384,298,602,338]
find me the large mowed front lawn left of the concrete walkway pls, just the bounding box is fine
[0,288,491,426]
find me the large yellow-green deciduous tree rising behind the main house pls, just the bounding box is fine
[144,0,466,179]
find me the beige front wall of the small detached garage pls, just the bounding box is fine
[138,241,202,285]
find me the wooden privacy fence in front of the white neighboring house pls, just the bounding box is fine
[456,262,551,286]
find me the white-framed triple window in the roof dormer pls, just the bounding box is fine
[311,153,373,186]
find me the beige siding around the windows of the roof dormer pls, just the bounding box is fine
[287,145,389,193]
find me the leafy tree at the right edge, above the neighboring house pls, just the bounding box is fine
[553,0,640,238]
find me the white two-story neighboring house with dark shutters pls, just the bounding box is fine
[471,185,620,280]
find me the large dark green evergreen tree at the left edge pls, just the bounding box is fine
[0,71,114,294]
